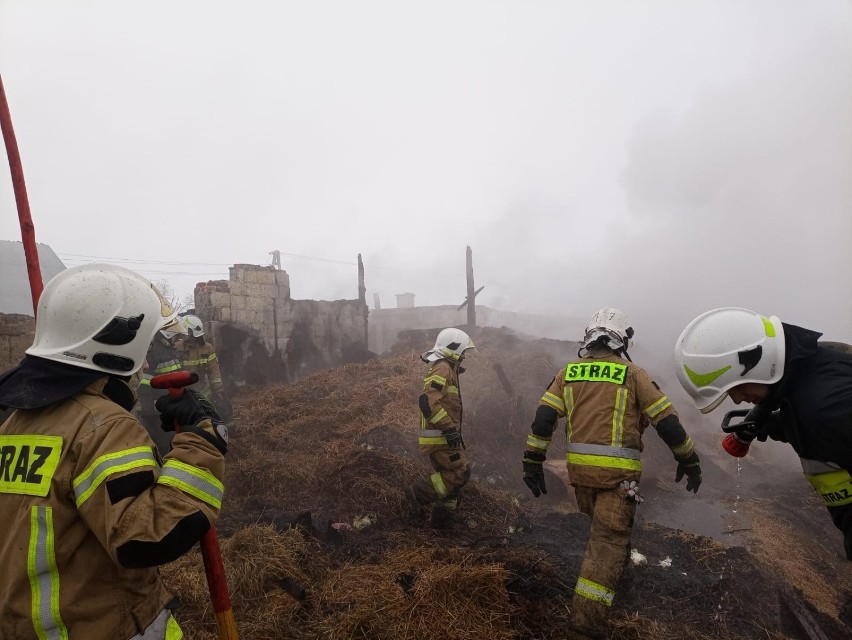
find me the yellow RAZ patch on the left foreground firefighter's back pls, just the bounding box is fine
[0,435,62,498]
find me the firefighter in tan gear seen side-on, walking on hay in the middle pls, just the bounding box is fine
[405,328,476,530]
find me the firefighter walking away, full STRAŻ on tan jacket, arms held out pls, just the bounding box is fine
[523,307,701,638]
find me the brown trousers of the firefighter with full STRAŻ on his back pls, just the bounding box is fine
[572,487,636,627]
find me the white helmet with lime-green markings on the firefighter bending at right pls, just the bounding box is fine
[674,307,785,413]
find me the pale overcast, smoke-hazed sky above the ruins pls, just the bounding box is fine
[0,0,852,355]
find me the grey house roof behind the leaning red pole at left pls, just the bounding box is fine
[0,240,65,316]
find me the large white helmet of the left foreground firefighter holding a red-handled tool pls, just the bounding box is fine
[26,264,182,376]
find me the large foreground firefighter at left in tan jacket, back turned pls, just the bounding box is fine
[0,264,227,640]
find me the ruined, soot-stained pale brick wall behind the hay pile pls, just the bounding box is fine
[195,264,369,391]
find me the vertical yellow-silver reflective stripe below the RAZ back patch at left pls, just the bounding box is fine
[27,506,68,640]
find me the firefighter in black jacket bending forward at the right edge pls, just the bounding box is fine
[675,307,852,560]
